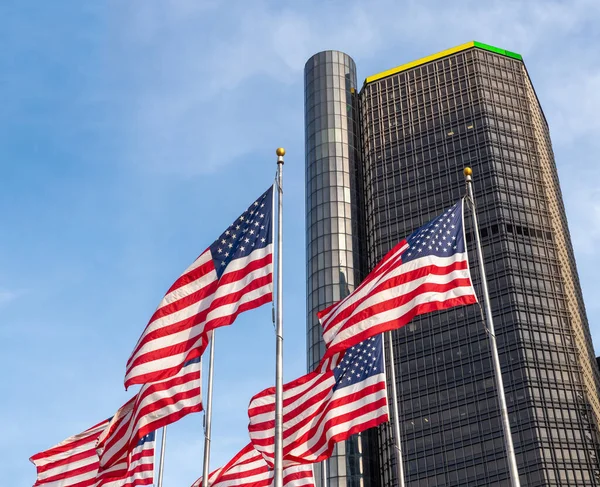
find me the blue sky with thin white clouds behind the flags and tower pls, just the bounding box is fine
[0,0,600,487]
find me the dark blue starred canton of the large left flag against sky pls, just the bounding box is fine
[210,186,273,279]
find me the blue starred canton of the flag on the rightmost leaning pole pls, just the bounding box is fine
[402,200,465,262]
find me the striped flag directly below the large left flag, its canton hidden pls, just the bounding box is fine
[96,357,202,485]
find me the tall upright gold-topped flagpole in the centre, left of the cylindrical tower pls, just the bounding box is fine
[273,147,285,487]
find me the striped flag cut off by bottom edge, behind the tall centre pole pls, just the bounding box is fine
[192,443,315,487]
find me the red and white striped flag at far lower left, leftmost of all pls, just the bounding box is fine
[30,419,110,487]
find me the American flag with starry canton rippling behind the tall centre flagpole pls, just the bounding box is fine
[248,335,388,466]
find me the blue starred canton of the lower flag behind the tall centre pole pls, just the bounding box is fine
[333,335,384,391]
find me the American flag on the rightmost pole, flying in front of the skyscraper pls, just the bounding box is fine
[318,200,477,370]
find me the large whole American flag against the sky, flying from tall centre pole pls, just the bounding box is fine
[125,187,273,388]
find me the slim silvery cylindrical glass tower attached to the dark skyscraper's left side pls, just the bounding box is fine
[304,51,365,486]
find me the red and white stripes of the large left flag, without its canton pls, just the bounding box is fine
[125,244,273,387]
